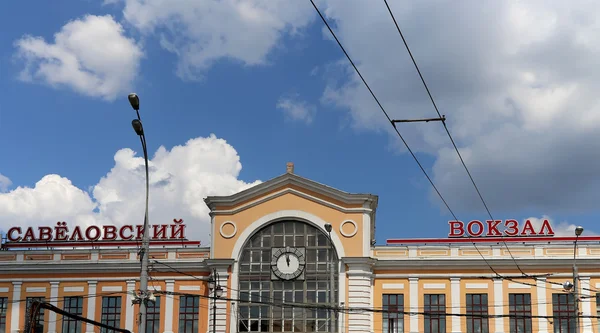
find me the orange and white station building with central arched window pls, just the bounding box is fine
[0,165,600,333]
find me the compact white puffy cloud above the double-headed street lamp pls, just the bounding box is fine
[15,15,143,100]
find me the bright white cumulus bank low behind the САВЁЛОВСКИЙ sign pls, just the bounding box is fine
[0,135,259,245]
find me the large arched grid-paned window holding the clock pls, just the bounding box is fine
[237,221,339,332]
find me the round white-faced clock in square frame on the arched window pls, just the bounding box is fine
[271,246,306,280]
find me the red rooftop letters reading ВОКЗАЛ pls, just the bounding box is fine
[448,220,554,237]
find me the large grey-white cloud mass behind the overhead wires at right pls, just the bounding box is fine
[321,0,600,214]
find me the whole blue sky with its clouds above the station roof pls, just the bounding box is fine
[0,0,600,243]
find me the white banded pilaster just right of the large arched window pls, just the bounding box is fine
[346,258,372,333]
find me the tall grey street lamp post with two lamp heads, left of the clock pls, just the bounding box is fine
[127,94,150,333]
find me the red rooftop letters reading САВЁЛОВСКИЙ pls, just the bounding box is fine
[6,219,185,242]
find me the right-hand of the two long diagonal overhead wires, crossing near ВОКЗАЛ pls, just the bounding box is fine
[382,0,529,276]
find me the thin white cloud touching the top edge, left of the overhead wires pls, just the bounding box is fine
[115,0,314,79]
